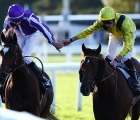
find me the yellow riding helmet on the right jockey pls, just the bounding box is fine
[99,6,115,21]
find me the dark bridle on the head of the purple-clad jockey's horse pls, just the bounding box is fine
[1,44,25,73]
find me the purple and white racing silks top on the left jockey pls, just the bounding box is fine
[3,10,55,43]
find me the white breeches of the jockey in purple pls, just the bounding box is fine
[17,31,40,64]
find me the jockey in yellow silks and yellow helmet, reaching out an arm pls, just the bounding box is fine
[63,6,140,93]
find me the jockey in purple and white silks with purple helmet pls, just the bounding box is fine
[3,4,63,92]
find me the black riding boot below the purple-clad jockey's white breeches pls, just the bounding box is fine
[28,62,50,93]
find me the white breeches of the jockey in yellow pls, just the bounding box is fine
[107,32,136,61]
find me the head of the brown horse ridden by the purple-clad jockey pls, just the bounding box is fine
[0,31,22,83]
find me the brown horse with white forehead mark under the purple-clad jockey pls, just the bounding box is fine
[0,31,58,120]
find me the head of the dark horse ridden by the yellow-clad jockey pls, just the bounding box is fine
[79,44,105,96]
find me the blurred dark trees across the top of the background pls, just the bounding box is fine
[0,0,140,30]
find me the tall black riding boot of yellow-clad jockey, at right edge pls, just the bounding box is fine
[124,59,140,96]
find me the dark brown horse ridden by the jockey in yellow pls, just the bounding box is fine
[79,44,140,120]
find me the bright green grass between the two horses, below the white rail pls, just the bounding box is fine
[53,73,94,120]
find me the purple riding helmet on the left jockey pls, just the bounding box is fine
[8,4,24,22]
